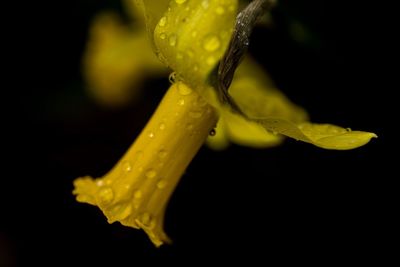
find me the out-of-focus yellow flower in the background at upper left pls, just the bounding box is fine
[83,13,166,106]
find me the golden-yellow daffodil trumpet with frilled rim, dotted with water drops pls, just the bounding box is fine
[73,83,217,246]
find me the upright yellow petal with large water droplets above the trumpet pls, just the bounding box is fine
[154,0,238,95]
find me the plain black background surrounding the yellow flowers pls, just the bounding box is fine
[0,0,398,267]
